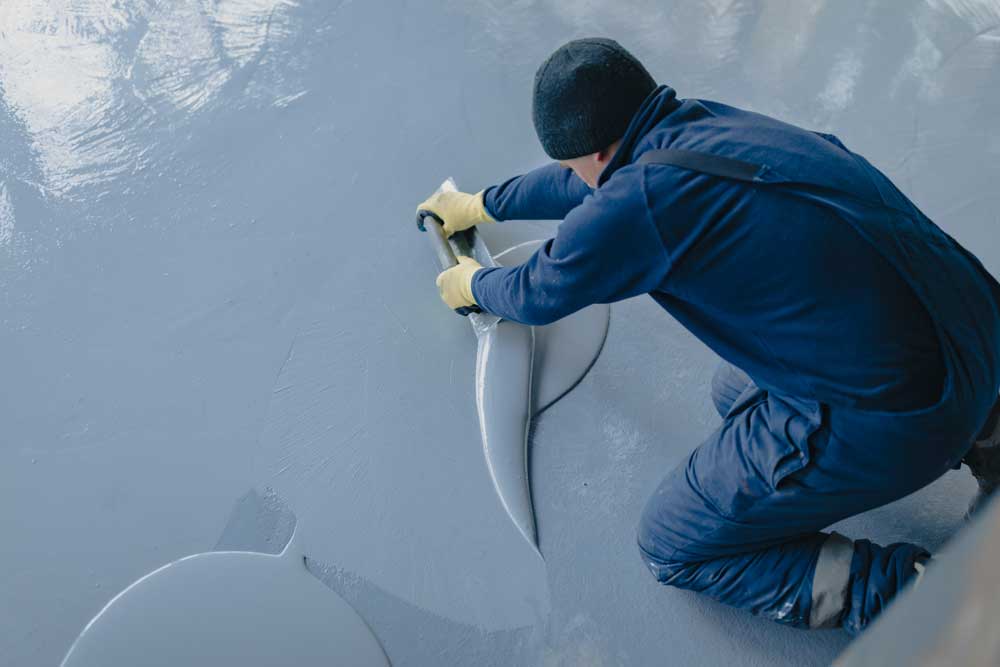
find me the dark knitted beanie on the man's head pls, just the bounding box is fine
[531,37,656,160]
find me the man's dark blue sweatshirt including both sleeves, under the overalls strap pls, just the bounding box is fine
[484,86,964,411]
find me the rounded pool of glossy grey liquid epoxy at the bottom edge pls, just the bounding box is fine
[62,536,389,667]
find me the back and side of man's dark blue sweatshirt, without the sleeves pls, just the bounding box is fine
[628,92,945,410]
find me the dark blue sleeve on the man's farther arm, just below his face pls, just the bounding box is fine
[483,162,592,220]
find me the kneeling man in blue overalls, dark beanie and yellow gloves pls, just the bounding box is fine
[418,39,1000,634]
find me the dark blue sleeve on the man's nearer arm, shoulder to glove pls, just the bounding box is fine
[472,167,670,325]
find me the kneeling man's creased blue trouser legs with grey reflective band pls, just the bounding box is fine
[639,363,932,633]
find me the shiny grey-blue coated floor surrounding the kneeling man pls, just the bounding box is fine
[0,0,1000,665]
